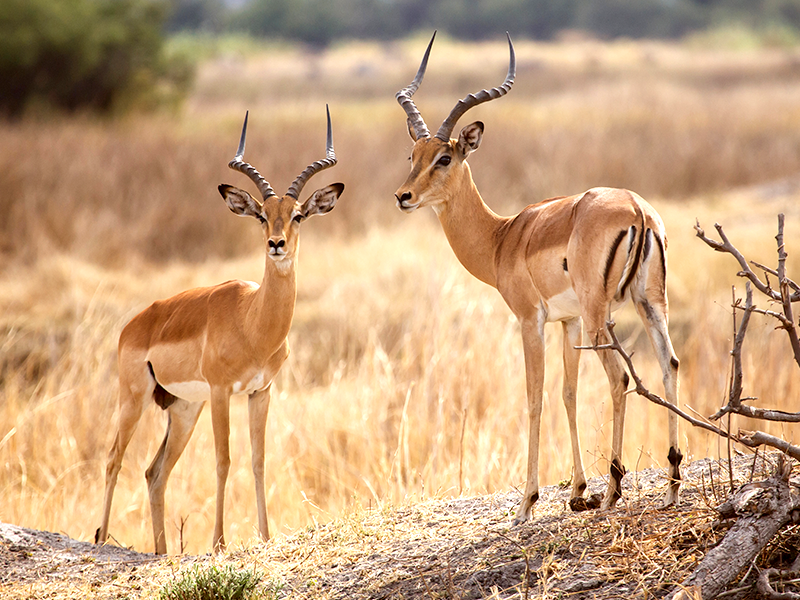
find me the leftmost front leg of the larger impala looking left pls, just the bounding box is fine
[514,318,544,525]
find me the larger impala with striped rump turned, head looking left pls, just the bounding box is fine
[395,32,682,524]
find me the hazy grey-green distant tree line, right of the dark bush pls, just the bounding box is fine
[217,0,800,45]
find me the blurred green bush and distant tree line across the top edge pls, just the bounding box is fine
[0,0,800,117]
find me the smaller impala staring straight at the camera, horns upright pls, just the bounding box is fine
[95,109,344,554]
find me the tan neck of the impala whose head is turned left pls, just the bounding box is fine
[434,163,508,287]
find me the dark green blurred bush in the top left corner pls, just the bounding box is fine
[0,0,193,117]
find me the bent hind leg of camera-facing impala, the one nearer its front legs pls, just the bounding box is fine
[145,398,205,554]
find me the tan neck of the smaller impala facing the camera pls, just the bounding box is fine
[247,254,297,345]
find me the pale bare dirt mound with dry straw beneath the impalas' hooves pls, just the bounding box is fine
[0,457,796,600]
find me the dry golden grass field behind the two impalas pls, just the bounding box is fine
[0,32,800,597]
